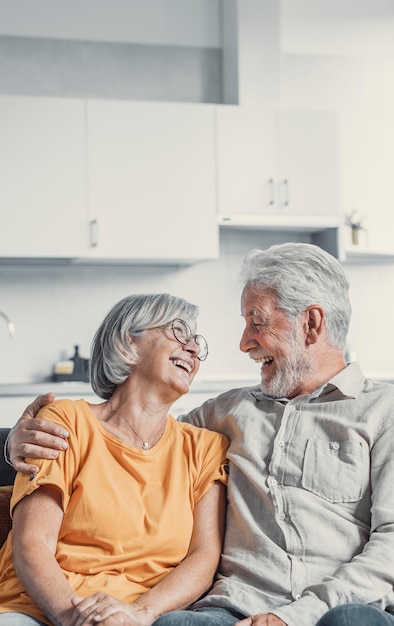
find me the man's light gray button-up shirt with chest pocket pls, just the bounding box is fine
[182,363,394,626]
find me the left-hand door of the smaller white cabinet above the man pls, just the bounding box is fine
[216,105,277,216]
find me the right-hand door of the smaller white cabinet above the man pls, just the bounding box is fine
[277,111,339,217]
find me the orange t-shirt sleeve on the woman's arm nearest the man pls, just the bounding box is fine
[194,429,229,503]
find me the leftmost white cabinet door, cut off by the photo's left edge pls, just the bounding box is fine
[0,97,88,258]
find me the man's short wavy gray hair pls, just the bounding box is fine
[241,243,351,349]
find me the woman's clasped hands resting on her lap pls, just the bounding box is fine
[69,591,157,626]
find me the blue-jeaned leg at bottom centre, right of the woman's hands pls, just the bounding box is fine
[152,606,245,626]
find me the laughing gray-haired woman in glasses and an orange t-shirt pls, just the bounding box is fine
[0,294,228,626]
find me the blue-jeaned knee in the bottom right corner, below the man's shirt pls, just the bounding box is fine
[316,604,394,626]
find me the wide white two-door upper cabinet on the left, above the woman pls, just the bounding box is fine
[0,97,219,264]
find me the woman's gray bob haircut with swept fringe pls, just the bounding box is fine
[89,293,199,400]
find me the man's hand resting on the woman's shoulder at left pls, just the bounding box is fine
[8,393,69,474]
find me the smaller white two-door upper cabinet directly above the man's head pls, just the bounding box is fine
[217,106,339,227]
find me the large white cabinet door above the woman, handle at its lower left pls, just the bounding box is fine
[87,100,218,262]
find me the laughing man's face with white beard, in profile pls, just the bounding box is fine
[240,288,313,398]
